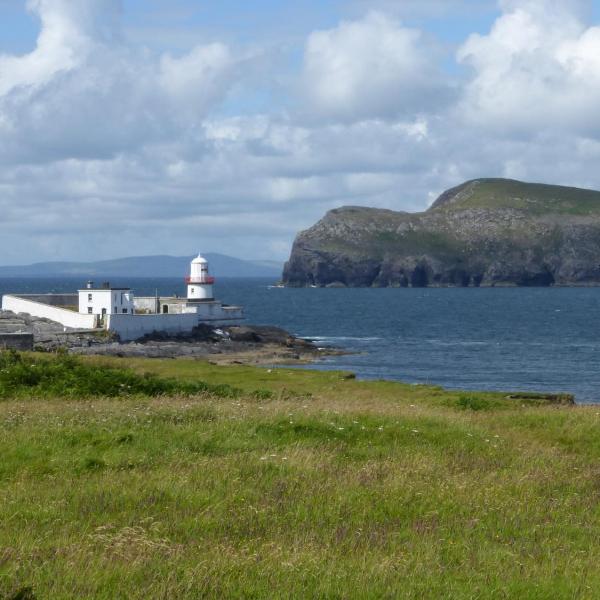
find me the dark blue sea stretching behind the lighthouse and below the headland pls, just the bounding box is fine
[0,279,600,402]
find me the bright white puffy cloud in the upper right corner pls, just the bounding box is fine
[458,0,600,136]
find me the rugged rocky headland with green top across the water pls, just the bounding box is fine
[283,179,600,287]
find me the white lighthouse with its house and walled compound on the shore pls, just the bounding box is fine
[2,255,244,341]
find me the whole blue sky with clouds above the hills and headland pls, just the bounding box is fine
[0,0,600,265]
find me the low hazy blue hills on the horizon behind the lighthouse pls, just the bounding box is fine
[0,252,283,278]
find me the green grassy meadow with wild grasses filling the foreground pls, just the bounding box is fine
[0,359,600,599]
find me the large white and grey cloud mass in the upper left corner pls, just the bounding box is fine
[0,0,247,162]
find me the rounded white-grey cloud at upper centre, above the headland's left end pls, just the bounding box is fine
[303,12,450,121]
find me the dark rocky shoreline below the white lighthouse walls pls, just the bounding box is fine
[0,311,340,365]
